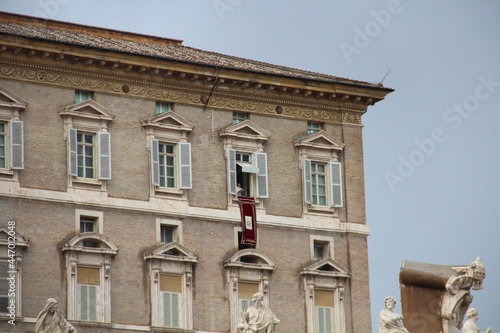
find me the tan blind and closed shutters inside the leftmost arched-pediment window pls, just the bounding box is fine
[76,266,101,321]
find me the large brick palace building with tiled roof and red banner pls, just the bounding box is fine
[0,13,392,333]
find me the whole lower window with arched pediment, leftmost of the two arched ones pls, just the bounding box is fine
[62,232,118,323]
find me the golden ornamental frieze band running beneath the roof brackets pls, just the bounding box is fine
[0,59,365,125]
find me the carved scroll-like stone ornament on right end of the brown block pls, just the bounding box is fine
[441,257,486,333]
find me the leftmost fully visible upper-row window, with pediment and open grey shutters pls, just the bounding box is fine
[60,99,114,190]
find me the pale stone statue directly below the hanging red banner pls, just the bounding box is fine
[238,293,280,333]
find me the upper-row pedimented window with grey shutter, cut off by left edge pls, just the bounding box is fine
[0,86,28,181]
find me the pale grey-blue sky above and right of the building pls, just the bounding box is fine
[0,0,500,332]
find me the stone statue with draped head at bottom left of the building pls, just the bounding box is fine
[35,298,76,333]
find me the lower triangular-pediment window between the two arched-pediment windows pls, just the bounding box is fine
[144,242,198,330]
